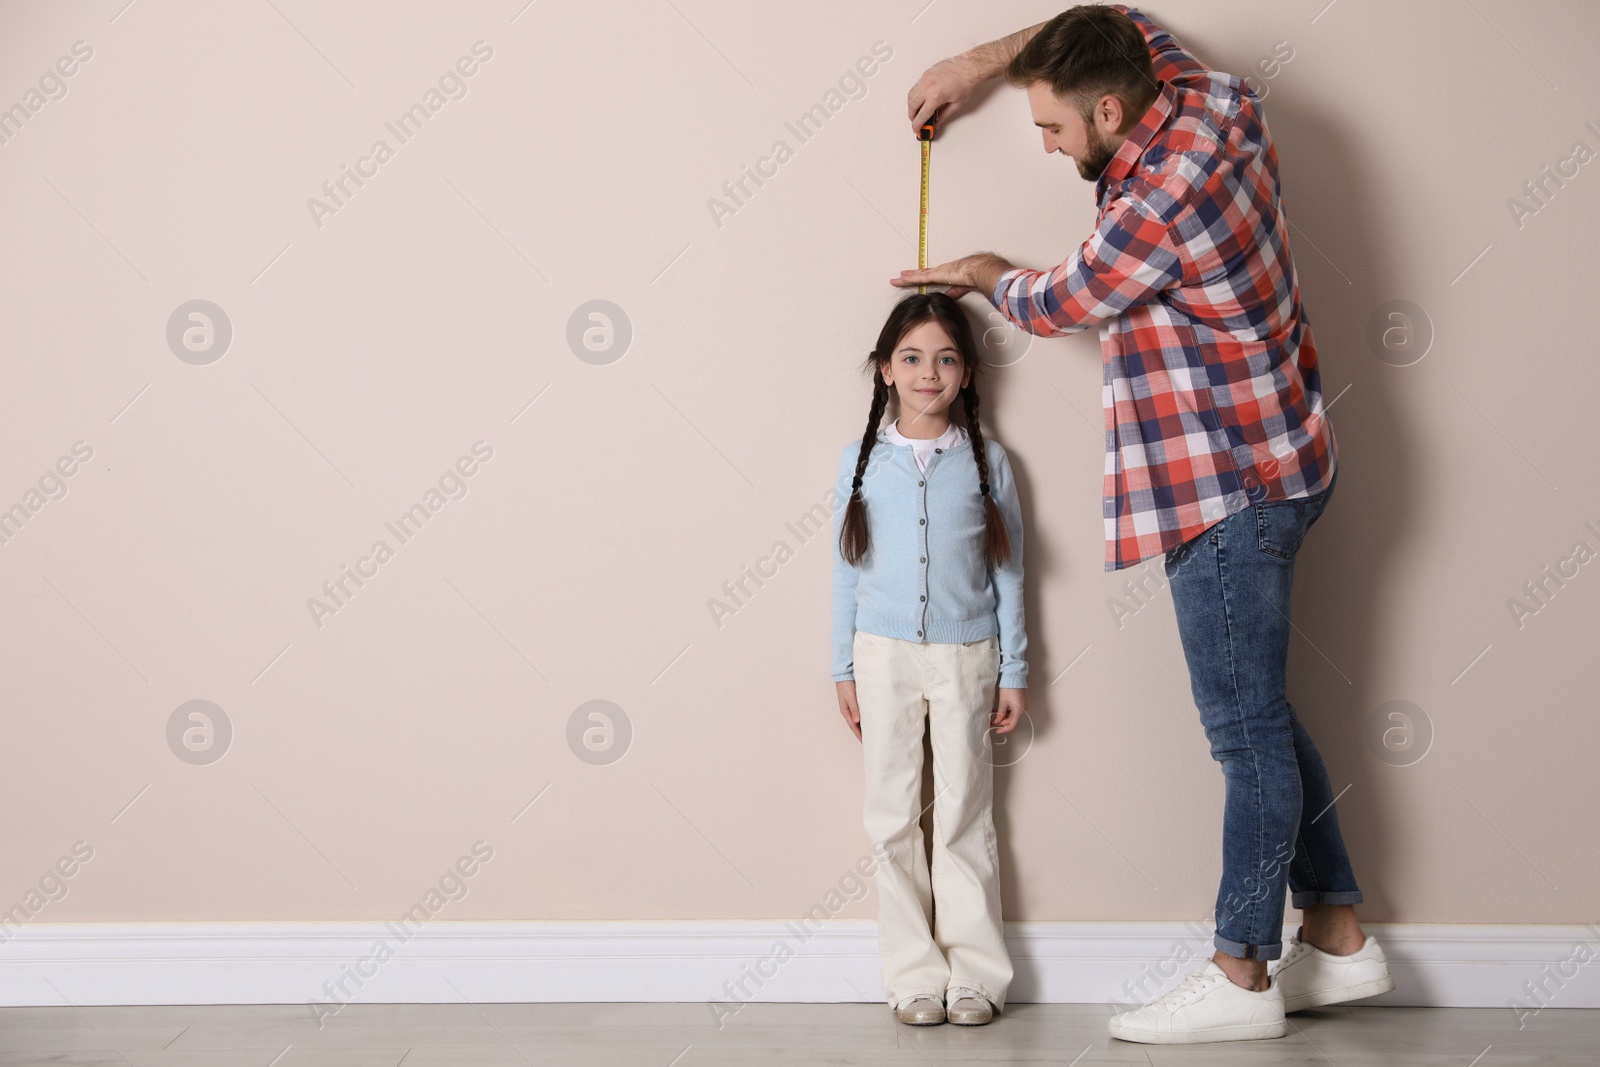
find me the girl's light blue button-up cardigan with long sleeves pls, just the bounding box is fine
[832,430,1027,689]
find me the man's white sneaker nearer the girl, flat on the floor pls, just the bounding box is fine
[1110,960,1288,1045]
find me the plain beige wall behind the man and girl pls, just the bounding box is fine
[0,0,1600,923]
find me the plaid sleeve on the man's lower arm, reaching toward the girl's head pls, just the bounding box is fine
[989,197,1182,338]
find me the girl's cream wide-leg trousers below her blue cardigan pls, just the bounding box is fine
[854,630,1011,1011]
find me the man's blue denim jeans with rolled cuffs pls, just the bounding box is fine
[1165,477,1362,960]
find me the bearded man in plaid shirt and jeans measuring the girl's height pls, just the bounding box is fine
[893,3,1394,1043]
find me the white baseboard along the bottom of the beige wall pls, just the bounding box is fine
[0,920,1600,1016]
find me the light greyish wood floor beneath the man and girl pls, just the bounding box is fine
[0,1005,1600,1067]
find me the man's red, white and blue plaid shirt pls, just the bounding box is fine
[989,3,1336,571]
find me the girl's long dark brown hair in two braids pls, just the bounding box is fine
[838,293,1011,569]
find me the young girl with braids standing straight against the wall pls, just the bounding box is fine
[832,293,1027,1025]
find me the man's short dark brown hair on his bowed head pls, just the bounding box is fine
[1005,3,1155,133]
